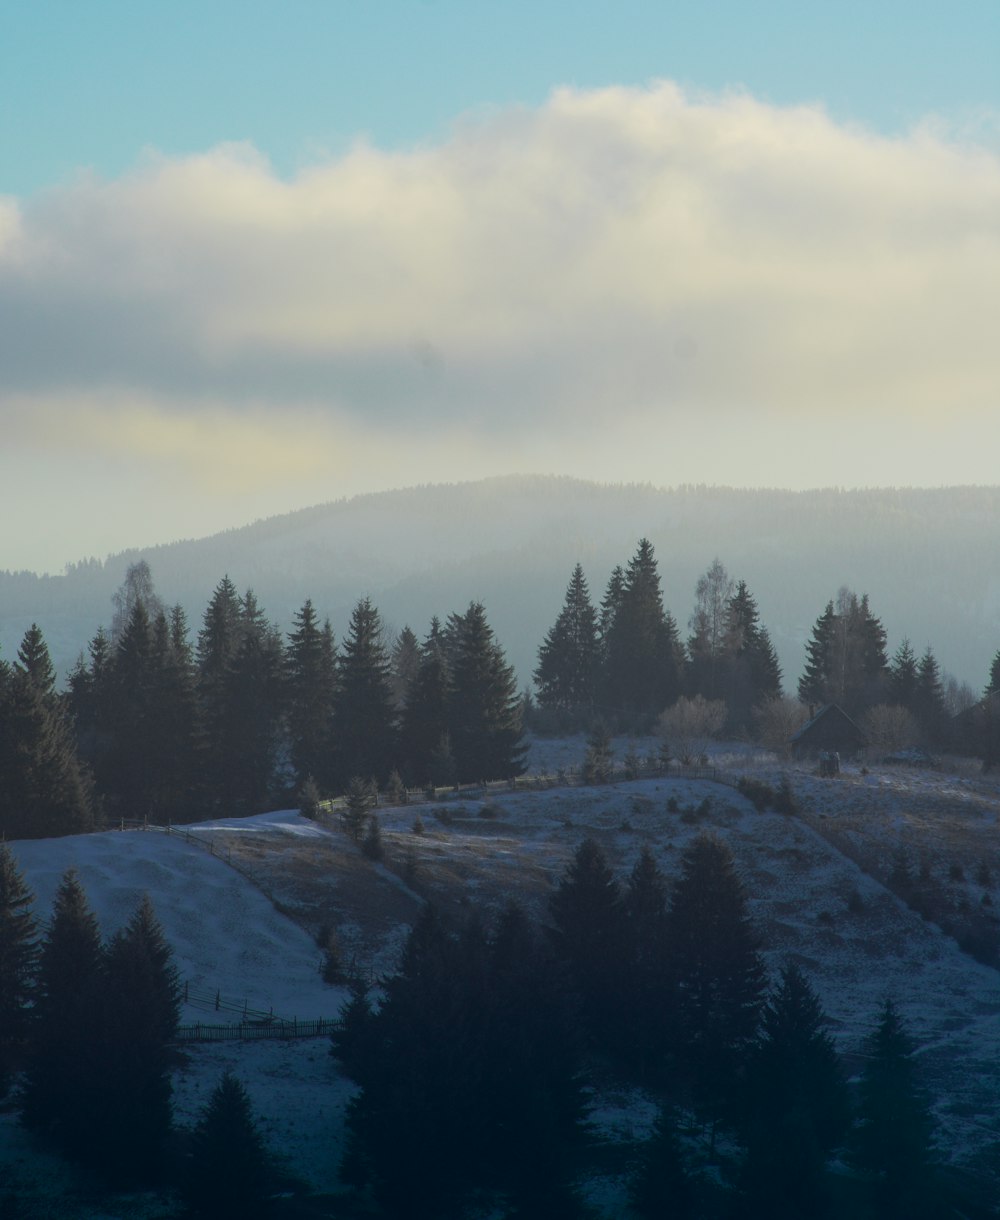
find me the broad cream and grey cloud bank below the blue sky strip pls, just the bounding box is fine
[0,83,1000,566]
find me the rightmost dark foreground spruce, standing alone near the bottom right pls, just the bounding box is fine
[854,1000,939,1220]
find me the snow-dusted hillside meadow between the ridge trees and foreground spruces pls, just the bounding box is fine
[0,738,1000,1216]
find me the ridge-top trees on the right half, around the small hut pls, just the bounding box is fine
[534,539,1000,763]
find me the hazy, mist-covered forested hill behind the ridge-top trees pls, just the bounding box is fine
[0,476,1000,691]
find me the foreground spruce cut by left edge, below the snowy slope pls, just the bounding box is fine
[0,841,38,1098]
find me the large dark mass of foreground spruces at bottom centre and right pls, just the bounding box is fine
[333,834,951,1220]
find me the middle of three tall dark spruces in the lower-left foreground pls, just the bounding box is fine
[22,869,104,1155]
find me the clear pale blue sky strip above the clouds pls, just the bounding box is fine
[0,0,1000,195]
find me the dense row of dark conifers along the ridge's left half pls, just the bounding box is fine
[0,564,524,837]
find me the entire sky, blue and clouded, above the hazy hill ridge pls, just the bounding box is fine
[0,0,1000,572]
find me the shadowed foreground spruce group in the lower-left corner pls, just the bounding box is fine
[0,842,277,1218]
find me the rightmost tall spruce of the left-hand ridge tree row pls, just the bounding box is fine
[445,601,527,782]
